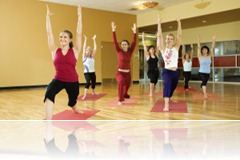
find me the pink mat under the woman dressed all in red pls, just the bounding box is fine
[105,98,139,107]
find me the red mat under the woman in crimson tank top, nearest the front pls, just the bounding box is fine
[52,110,100,120]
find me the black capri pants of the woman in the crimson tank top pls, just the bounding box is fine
[44,79,79,107]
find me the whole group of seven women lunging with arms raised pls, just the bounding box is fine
[44,6,216,120]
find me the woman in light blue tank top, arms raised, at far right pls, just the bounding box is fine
[197,35,216,99]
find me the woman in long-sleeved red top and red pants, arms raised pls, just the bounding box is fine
[112,22,137,105]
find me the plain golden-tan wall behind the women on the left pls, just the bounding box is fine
[0,0,138,87]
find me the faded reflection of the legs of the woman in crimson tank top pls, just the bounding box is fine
[44,121,79,159]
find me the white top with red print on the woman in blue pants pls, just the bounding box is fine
[163,47,178,69]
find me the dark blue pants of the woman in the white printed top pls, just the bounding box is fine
[162,69,178,98]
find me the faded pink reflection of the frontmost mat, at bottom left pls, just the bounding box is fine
[53,121,99,131]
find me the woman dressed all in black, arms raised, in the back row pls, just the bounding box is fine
[142,32,159,97]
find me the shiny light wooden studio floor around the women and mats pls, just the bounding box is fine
[0,82,240,120]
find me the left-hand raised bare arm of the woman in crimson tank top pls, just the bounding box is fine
[46,5,57,58]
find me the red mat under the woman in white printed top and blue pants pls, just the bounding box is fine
[151,100,188,113]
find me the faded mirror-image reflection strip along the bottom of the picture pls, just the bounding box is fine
[0,121,240,160]
